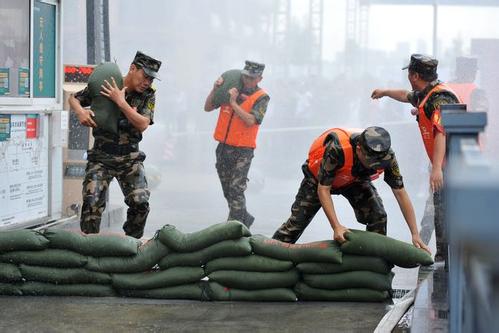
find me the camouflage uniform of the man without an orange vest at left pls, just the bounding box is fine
[74,52,161,238]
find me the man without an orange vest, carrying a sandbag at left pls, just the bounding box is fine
[69,51,161,238]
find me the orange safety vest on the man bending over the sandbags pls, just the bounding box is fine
[308,128,384,189]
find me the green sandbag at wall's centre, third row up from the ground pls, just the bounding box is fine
[204,254,293,275]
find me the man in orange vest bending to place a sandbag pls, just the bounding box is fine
[273,126,429,252]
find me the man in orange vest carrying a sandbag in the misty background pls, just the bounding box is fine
[204,60,270,228]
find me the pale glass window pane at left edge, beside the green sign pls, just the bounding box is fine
[0,0,30,98]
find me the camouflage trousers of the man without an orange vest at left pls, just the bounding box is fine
[80,152,150,238]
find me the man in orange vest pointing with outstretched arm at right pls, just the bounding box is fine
[371,54,460,261]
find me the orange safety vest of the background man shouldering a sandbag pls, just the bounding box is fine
[213,89,267,148]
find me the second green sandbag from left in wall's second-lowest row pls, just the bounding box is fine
[19,264,111,284]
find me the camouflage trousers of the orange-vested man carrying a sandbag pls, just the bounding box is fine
[215,143,255,227]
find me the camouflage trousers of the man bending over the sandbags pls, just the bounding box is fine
[272,175,387,243]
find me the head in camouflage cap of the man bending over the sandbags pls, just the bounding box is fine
[359,126,392,169]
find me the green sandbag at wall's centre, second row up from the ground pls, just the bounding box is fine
[208,269,300,290]
